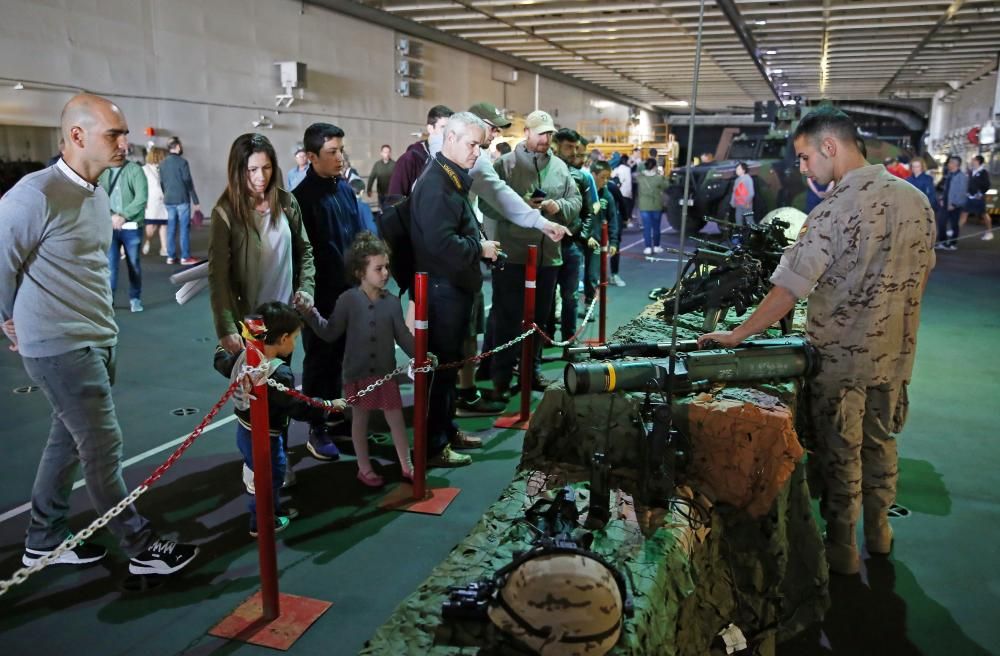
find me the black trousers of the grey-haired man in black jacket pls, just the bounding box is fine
[427,276,472,458]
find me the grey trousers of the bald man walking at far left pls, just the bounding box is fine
[23,347,155,556]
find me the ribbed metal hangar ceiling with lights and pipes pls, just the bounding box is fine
[357,0,1000,112]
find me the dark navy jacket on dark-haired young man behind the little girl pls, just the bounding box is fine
[292,166,364,316]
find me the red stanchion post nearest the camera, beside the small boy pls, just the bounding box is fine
[247,328,281,621]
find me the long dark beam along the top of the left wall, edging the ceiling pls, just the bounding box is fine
[305,0,660,114]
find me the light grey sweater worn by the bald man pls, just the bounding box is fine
[0,164,118,358]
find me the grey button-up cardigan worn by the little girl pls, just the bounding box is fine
[306,287,413,383]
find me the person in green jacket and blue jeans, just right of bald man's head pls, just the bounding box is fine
[98,161,149,312]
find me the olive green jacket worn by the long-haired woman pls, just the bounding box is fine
[208,190,316,339]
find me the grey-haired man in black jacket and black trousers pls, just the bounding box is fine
[410,112,499,467]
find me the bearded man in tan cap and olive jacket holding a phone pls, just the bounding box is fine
[483,110,582,398]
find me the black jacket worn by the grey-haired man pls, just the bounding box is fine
[410,153,483,293]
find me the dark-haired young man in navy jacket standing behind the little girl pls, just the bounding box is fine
[289,123,363,462]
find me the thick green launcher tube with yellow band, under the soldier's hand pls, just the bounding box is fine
[563,337,820,394]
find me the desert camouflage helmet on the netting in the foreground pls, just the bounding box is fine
[488,549,626,656]
